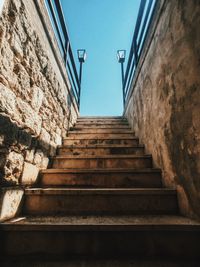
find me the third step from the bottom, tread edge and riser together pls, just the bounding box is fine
[40,169,162,188]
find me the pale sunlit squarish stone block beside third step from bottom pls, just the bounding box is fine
[21,162,39,185]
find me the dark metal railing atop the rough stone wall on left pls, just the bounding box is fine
[45,0,81,109]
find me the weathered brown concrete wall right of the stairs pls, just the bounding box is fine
[125,0,200,220]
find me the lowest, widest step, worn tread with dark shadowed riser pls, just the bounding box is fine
[0,215,200,260]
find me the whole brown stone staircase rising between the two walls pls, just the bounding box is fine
[0,117,200,260]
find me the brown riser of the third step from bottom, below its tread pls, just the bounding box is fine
[40,172,162,188]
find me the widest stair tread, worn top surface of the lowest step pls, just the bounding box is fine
[1,215,200,231]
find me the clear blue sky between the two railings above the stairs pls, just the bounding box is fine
[61,0,140,116]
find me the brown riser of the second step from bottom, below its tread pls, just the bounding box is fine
[23,193,177,216]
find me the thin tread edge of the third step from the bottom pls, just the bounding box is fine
[41,168,161,173]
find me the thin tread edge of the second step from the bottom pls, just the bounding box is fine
[25,187,177,195]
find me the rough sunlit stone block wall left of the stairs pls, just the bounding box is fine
[0,0,78,221]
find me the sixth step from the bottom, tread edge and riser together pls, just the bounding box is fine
[63,136,139,146]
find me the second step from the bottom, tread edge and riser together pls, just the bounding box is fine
[23,187,178,215]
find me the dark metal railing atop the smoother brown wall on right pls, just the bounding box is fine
[123,0,157,107]
